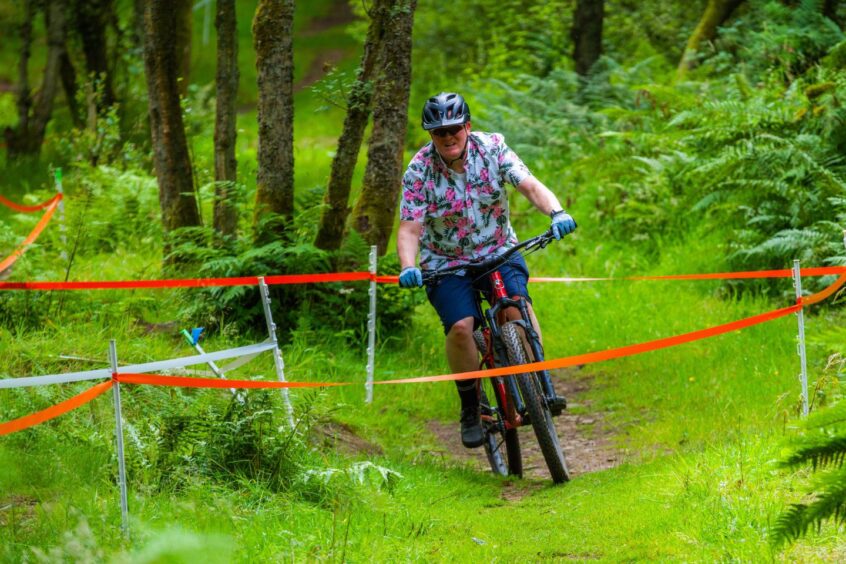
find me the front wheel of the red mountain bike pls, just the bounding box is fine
[501,322,570,484]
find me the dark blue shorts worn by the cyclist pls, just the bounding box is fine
[426,253,532,335]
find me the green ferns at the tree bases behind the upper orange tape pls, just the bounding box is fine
[173,214,422,342]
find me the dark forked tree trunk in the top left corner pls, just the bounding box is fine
[5,0,66,157]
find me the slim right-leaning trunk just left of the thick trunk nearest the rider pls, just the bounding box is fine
[314,0,396,250]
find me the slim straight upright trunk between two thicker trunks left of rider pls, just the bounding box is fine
[214,0,239,241]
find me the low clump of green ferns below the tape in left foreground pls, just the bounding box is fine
[129,390,315,491]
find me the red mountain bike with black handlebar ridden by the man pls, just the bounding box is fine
[423,231,570,483]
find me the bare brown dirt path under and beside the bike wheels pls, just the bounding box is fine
[428,370,624,492]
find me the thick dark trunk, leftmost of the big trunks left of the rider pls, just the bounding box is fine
[144,0,200,247]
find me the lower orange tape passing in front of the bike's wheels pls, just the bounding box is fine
[0,274,846,435]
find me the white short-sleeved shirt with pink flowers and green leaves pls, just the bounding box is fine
[400,132,531,270]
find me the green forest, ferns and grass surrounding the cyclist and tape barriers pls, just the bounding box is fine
[0,0,846,562]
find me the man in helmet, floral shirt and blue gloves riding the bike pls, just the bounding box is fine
[397,92,576,448]
